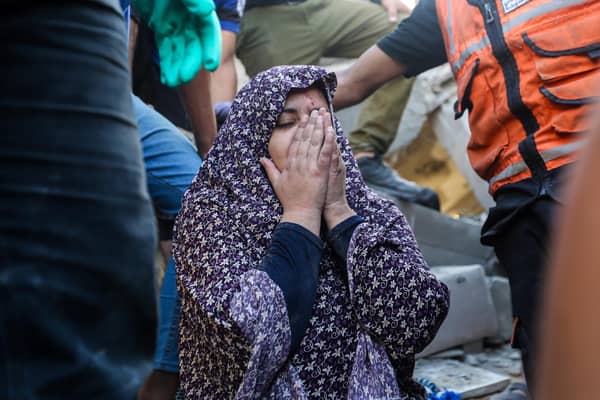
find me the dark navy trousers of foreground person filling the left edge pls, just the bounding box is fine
[0,0,156,400]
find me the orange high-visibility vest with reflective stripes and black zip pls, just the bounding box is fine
[436,0,600,194]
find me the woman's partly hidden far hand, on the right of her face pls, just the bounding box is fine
[322,110,356,230]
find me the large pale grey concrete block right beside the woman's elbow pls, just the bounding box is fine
[418,265,498,357]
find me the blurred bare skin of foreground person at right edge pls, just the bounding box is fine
[536,107,600,400]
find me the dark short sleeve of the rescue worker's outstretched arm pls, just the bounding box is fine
[377,0,447,76]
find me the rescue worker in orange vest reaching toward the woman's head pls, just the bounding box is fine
[334,0,600,394]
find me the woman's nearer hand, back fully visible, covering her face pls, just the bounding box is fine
[260,111,336,236]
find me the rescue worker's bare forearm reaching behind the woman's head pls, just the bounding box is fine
[333,46,406,110]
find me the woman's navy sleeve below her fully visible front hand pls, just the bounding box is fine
[260,222,324,353]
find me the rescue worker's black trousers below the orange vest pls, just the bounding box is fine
[494,196,558,387]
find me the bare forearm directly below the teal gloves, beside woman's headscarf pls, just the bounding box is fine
[178,69,217,158]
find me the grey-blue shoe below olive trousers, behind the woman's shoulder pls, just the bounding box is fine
[356,155,440,211]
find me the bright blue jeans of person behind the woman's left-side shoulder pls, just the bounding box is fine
[132,96,202,372]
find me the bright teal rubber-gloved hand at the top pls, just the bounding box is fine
[133,0,221,86]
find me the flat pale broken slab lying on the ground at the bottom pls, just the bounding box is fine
[414,359,510,399]
